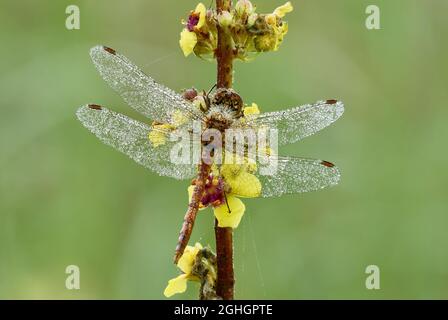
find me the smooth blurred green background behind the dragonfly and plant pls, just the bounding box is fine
[0,0,448,299]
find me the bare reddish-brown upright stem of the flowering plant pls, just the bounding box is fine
[215,0,235,300]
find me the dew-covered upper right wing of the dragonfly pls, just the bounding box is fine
[246,100,344,145]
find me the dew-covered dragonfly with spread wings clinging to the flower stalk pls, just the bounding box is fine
[76,46,344,263]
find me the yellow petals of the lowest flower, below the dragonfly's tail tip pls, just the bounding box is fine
[163,243,202,298]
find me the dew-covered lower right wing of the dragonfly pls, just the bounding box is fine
[231,156,340,197]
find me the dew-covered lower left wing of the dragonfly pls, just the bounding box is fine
[76,105,197,180]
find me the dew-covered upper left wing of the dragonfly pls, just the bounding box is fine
[90,46,201,123]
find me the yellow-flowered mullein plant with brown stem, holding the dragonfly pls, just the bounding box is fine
[164,0,293,299]
